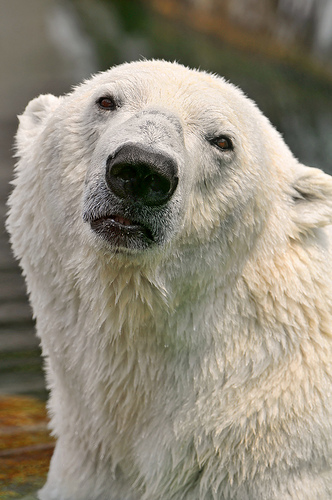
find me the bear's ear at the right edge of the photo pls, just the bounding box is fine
[292,165,332,231]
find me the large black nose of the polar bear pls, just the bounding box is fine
[106,144,178,206]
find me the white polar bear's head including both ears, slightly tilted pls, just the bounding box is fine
[10,61,332,280]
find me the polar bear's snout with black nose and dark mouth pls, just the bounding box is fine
[82,141,183,252]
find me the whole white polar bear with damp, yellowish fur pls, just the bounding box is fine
[8,60,332,500]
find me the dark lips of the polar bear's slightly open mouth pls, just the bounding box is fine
[90,214,154,249]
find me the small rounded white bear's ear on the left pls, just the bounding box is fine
[16,94,62,156]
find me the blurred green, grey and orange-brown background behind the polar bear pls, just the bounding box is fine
[0,0,332,499]
